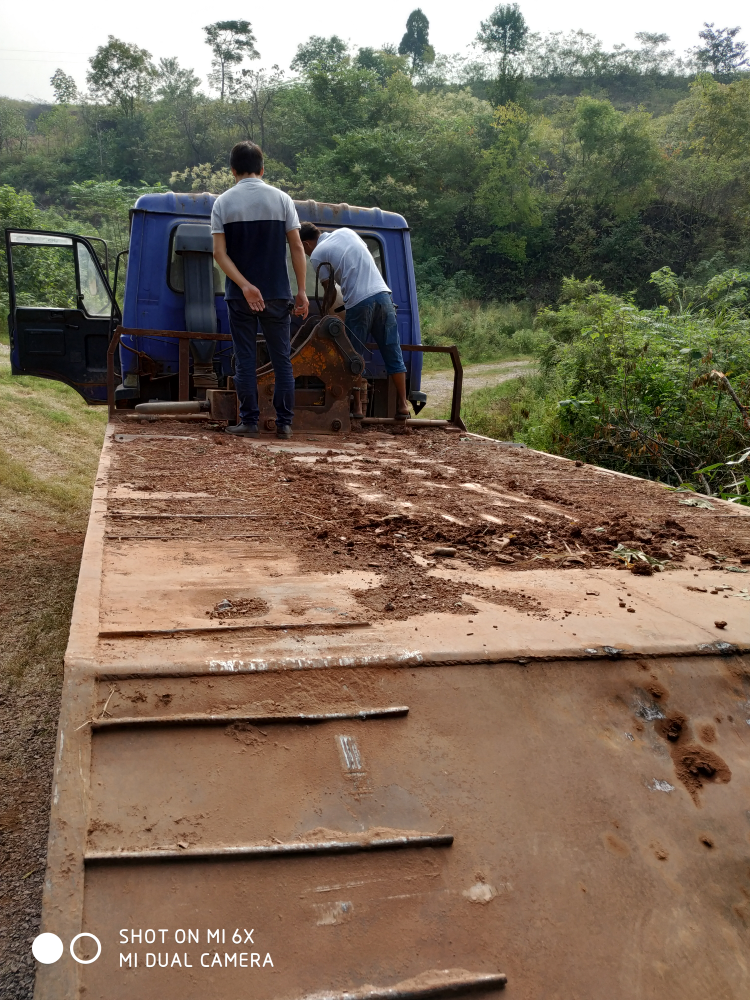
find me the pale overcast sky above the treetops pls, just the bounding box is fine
[0,0,750,101]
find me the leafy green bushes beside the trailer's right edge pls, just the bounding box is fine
[494,271,750,502]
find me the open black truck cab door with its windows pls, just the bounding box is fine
[5,229,120,403]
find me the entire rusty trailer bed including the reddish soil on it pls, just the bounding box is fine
[35,419,750,1000]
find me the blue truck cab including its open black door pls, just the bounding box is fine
[6,192,422,416]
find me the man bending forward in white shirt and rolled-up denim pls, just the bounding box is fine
[300,222,409,421]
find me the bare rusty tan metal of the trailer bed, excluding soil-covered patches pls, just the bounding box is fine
[35,422,750,1000]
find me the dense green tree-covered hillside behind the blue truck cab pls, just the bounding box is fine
[0,4,750,306]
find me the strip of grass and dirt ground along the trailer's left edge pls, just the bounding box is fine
[0,344,106,997]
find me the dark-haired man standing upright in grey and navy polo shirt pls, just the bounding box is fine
[211,142,308,438]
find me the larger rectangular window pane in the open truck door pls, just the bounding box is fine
[11,233,78,309]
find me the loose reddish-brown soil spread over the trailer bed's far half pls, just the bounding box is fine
[110,421,750,618]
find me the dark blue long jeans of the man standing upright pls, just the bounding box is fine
[227,298,294,427]
